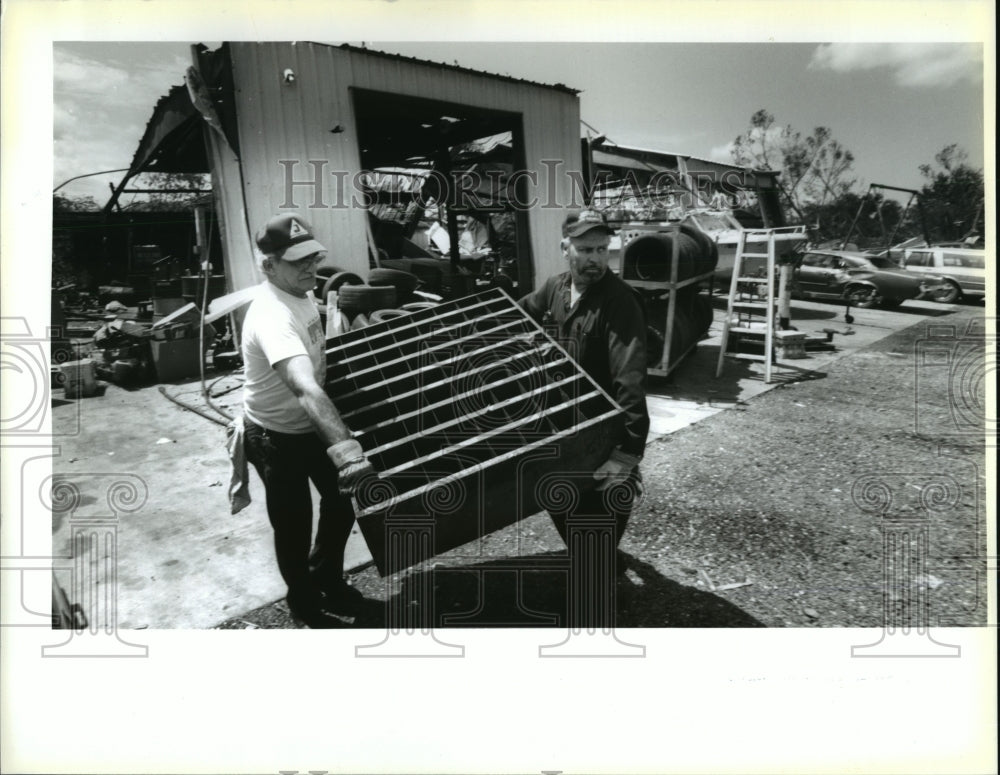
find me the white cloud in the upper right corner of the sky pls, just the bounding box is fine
[809,43,983,88]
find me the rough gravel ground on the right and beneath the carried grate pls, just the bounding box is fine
[220,307,995,629]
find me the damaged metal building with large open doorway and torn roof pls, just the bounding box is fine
[119,42,582,304]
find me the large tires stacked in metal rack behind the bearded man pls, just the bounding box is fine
[622,224,719,368]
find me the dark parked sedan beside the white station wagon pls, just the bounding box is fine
[792,250,942,308]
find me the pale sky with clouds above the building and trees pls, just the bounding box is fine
[53,40,984,209]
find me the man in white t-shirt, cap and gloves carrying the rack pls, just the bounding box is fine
[242,213,374,627]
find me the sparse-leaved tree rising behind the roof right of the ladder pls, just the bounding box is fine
[731,109,855,229]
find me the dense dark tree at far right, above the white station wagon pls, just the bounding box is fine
[918,143,986,242]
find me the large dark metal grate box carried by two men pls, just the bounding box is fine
[326,289,622,575]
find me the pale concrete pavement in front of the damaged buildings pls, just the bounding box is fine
[52,297,968,629]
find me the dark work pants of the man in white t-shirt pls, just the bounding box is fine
[244,418,354,598]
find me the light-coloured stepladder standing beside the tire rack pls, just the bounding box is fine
[715,229,777,383]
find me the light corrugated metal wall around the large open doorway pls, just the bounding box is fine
[223,43,581,290]
